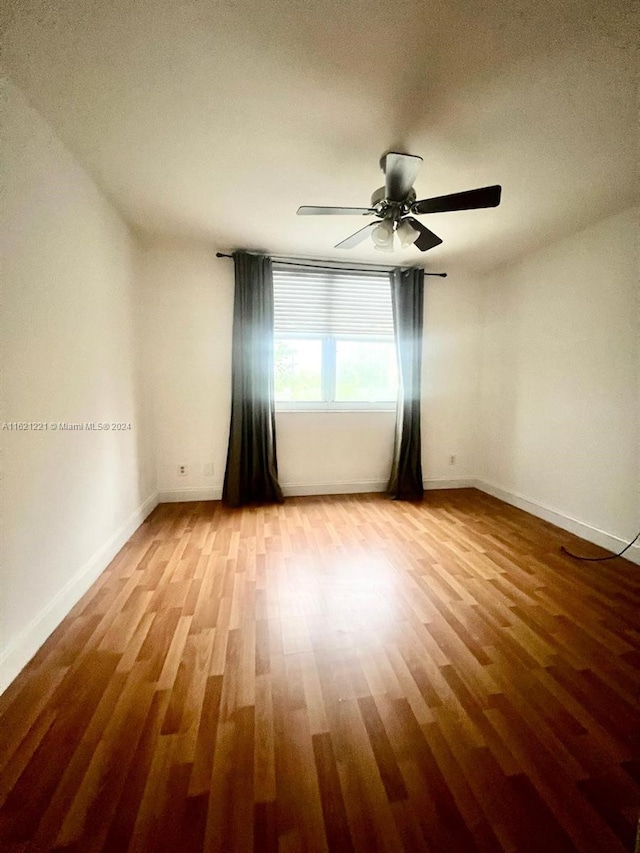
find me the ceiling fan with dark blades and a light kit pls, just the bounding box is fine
[298,151,502,252]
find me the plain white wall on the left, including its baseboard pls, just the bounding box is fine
[0,81,155,690]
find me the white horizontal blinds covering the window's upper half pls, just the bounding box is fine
[273,263,393,337]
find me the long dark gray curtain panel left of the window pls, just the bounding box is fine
[222,252,283,507]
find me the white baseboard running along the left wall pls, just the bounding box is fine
[0,493,158,694]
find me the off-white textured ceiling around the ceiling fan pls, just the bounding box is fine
[3,0,638,270]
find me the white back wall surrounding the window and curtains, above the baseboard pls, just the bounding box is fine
[139,239,481,500]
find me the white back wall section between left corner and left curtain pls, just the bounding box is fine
[142,240,234,500]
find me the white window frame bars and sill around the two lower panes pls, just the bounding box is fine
[274,332,398,412]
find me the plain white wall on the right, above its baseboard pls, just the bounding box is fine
[478,209,640,547]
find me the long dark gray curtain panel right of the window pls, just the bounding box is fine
[387,269,424,501]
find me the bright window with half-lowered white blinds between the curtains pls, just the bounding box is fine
[273,264,398,409]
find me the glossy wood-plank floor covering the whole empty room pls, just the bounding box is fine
[0,490,640,853]
